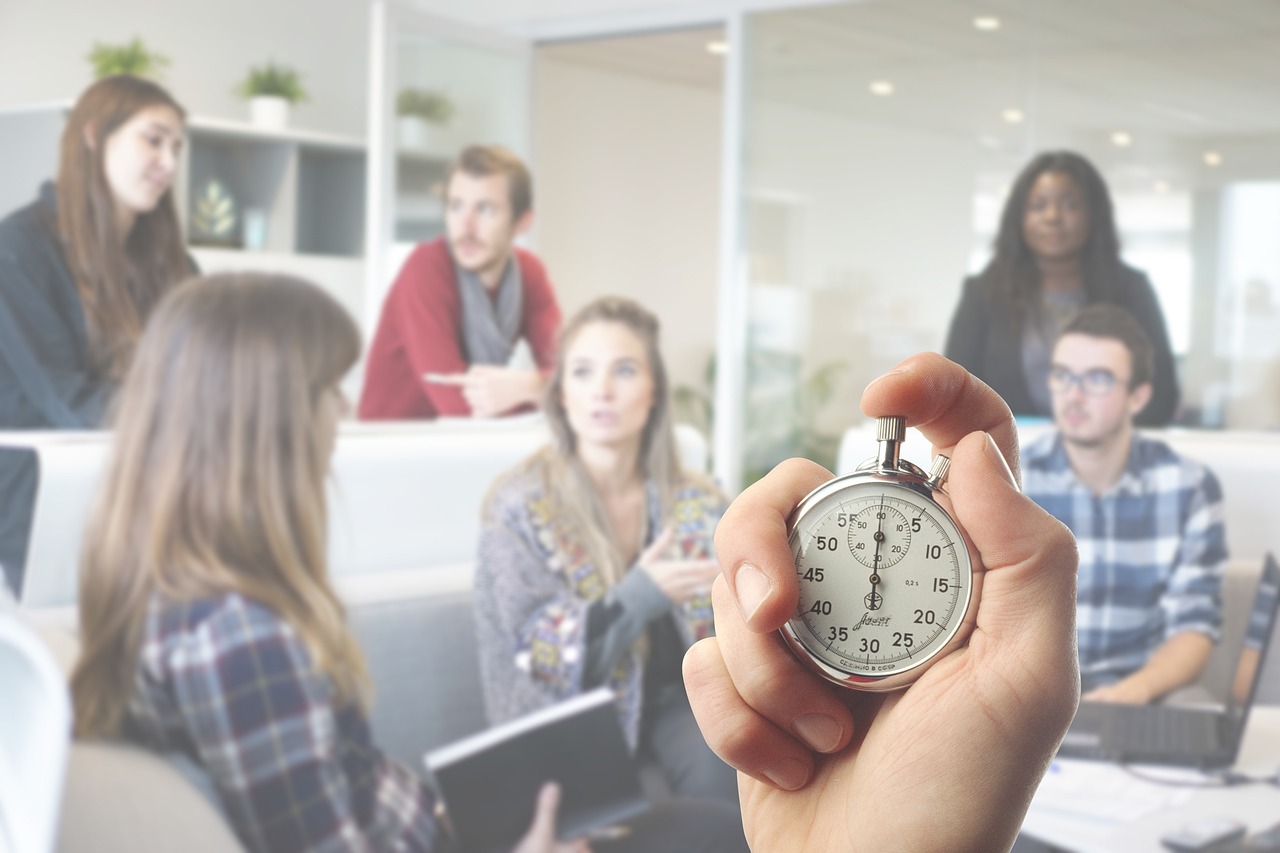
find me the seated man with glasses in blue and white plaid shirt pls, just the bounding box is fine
[1023,305,1226,704]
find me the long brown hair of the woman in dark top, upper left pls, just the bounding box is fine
[58,74,192,380]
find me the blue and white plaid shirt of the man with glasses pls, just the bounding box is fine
[1021,430,1226,690]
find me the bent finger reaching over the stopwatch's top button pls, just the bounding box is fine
[861,352,1021,483]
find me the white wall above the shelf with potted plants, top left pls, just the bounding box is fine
[0,0,369,136]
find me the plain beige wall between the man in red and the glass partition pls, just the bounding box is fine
[534,58,721,394]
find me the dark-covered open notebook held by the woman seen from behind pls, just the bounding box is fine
[425,688,649,853]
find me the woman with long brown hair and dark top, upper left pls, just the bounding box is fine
[0,76,195,590]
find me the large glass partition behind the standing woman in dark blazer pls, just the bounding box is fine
[717,0,1280,488]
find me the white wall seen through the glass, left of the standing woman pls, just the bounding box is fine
[744,101,977,434]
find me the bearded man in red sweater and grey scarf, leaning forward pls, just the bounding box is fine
[360,146,561,420]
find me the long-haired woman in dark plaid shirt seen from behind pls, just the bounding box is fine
[64,274,581,853]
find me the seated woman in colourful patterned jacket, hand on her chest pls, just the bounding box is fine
[475,297,737,806]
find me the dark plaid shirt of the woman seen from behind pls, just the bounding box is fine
[125,593,439,853]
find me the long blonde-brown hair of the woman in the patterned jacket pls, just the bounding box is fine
[529,296,689,585]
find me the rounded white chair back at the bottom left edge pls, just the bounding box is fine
[0,612,70,853]
